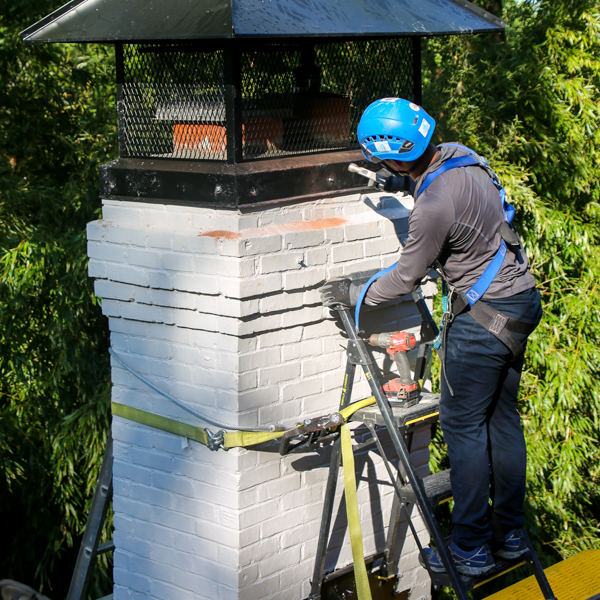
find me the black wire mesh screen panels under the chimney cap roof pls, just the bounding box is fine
[119,38,415,161]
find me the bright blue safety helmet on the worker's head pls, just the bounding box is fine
[357,98,435,163]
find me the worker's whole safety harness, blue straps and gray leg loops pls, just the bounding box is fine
[355,144,535,366]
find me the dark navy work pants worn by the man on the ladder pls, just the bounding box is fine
[440,288,542,549]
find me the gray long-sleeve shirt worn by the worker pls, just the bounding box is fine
[365,146,535,305]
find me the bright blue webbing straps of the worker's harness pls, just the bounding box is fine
[354,143,515,329]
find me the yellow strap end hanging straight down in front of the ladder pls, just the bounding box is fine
[341,422,371,600]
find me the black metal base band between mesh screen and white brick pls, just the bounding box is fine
[100,150,366,208]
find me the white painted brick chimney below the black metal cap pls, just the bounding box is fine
[88,193,430,600]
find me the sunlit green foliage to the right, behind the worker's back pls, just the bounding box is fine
[424,0,600,584]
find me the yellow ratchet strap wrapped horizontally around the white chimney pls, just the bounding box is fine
[111,398,375,449]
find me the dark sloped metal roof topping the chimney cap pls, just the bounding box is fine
[21,0,506,43]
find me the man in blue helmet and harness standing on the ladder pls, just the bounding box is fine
[321,98,542,576]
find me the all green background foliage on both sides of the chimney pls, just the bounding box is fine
[0,0,600,597]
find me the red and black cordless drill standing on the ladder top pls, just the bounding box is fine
[367,331,419,408]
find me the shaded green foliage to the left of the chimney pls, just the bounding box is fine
[0,0,116,597]
